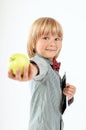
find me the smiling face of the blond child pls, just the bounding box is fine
[36,34,62,60]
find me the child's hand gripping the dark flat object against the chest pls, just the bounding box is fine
[63,83,76,100]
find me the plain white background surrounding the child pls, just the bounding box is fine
[0,0,86,130]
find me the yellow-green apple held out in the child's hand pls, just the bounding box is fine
[9,53,30,75]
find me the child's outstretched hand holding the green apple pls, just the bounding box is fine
[8,64,38,81]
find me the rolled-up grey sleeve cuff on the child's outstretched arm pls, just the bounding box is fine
[31,57,48,80]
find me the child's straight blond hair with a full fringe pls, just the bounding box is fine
[27,17,63,58]
